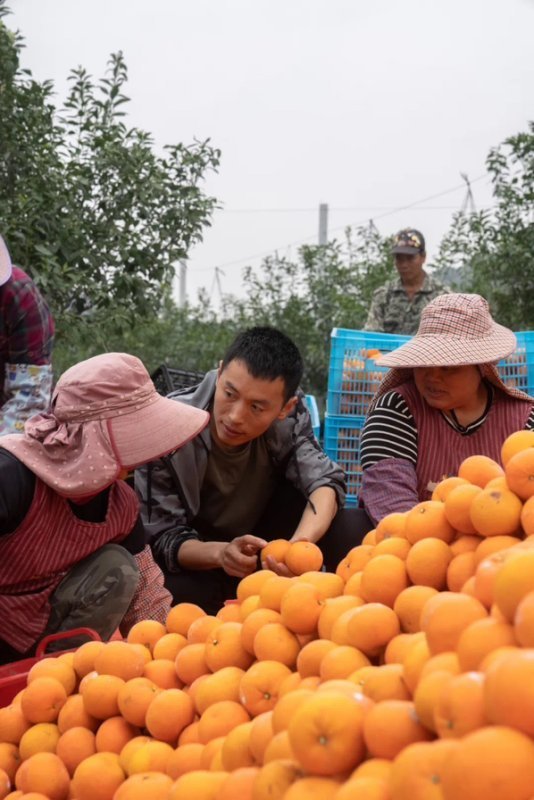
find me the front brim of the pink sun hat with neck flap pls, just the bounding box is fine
[108,395,210,469]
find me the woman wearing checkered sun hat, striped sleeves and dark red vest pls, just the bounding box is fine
[360,294,534,523]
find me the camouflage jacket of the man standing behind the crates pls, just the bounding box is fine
[364,274,450,336]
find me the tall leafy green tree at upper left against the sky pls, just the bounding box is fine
[0,0,220,342]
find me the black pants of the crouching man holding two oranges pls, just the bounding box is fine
[165,481,373,614]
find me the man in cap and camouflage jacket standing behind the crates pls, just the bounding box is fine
[364,228,449,336]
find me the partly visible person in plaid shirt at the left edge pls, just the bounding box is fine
[0,236,54,436]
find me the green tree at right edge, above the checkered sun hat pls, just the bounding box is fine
[437,122,534,330]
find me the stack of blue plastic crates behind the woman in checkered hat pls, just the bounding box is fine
[324,328,534,506]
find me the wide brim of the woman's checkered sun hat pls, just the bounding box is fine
[376,323,516,369]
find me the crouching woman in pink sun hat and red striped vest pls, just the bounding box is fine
[0,353,209,663]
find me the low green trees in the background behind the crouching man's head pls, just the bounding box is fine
[57,223,394,403]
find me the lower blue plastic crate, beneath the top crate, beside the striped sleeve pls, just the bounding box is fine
[323,414,365,507]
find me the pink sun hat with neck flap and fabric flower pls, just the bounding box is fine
[0,353,209,498]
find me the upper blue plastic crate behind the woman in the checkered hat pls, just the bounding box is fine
[326,328,534,417]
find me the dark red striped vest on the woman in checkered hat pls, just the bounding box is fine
[394,381,532,501]
